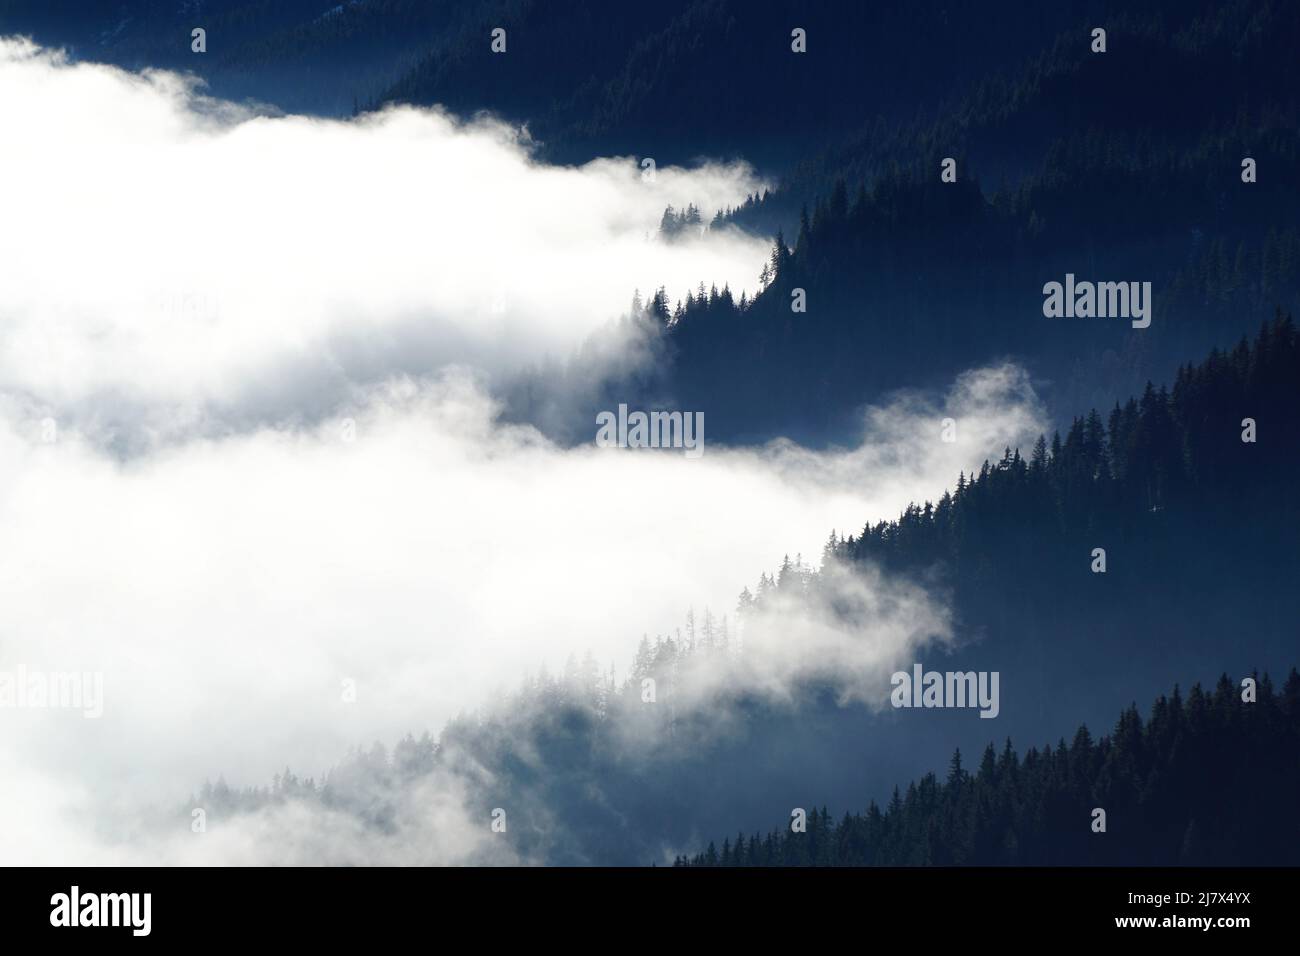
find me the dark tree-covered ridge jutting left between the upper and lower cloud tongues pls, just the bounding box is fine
[655,126,1300,442]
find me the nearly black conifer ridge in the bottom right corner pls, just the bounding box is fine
[676,669,1300,866]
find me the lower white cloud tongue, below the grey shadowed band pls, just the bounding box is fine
[0,372,1034,858]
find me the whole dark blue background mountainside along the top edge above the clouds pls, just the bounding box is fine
[0,0,1118,164]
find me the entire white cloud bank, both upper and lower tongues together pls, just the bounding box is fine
[0,40,1043,864]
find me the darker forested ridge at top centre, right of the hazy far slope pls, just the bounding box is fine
[369,0,1107,164]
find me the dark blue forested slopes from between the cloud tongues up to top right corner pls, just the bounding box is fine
[670,4,1300,442]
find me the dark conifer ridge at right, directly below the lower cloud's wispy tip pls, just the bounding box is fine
[832,315,1300,588]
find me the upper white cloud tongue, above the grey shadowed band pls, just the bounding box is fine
[0,39,767,439]
